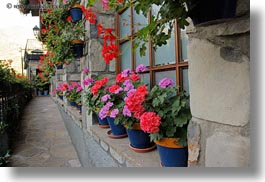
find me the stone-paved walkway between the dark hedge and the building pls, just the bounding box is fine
[9,96,81,167]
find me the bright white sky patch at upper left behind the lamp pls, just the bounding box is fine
[0,0,39,73]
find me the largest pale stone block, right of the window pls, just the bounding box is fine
[188,38,250,126]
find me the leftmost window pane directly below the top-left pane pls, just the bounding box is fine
[120,41,132,70]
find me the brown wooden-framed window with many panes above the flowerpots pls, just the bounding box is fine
[116,6,189,94]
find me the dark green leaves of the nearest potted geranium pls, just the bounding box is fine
[145,85,191,146]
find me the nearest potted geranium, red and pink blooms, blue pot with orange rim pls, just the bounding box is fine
[126,78,191,167]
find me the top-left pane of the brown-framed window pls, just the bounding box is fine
[120,8,131,39]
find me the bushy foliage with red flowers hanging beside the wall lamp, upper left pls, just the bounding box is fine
[41,0,85,65]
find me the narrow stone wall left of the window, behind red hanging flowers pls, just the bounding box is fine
[80,0,116,132]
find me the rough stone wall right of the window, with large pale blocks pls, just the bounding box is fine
[188,0,250,167]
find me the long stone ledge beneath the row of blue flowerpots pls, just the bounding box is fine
[52,97,160,167]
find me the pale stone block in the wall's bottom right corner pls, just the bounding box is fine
[205,132,250,167]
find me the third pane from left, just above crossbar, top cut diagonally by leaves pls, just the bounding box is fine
[154,31,176,66]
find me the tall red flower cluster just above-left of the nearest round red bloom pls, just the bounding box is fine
[125,85,148,119]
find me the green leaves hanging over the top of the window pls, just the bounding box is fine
[125,0,190,55]
